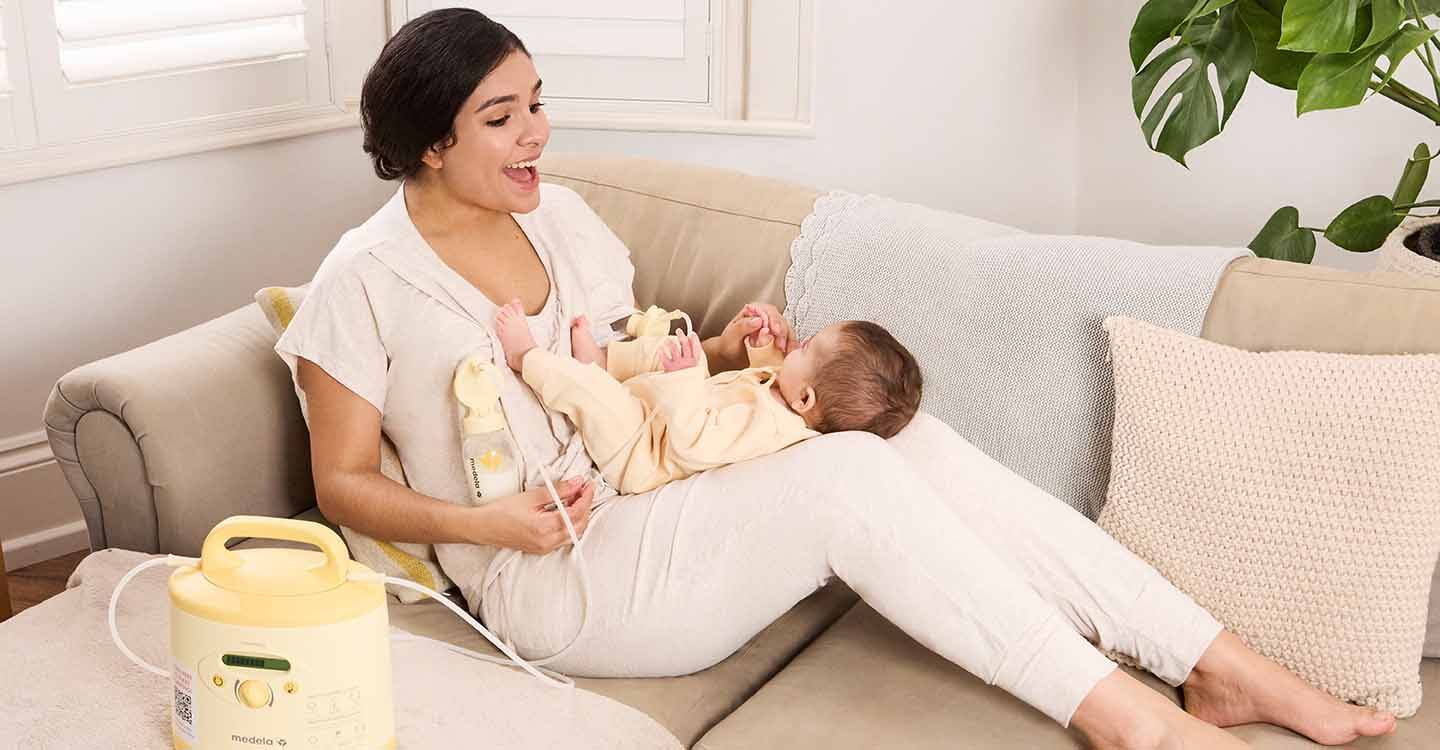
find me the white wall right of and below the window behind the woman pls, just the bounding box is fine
[541,0,1089,232]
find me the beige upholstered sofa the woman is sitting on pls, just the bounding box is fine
[45,155,1440,750]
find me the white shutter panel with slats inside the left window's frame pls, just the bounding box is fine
[22,0,340,145]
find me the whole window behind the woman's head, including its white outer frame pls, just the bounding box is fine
[392,0,814,134]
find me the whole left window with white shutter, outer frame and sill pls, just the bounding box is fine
[0,0,360,184]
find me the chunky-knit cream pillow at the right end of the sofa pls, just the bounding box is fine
[1097,317,1440,715]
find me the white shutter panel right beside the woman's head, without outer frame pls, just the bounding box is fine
[409,0,713,105]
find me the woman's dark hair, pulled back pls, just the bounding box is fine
[360,7,530,180]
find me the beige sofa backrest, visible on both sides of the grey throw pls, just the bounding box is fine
[541,154,1440,354]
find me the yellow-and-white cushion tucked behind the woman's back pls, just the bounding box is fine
[255,286,454,605]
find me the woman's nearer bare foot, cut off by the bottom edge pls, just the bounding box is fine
[1070,669,1250,750]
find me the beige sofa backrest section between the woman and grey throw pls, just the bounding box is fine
[540,154,819,337]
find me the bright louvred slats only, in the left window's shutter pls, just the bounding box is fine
[55,0,310,83]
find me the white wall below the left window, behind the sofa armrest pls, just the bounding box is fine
[0,128,393,567]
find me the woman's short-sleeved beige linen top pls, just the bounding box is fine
[275,184,635,610]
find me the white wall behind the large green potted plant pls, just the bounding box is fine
[1076,0,1440,271]
